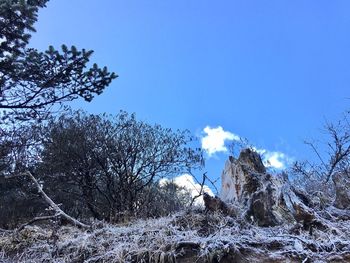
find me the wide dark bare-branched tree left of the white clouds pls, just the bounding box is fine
[39,112,203,222]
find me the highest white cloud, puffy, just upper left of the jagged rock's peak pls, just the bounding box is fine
[201,126,240,157]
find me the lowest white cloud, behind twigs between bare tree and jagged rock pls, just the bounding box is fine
[159,174,214,206]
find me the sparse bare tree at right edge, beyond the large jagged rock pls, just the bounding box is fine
[293,112,350,207]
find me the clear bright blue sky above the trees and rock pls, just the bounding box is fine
[31,0,350,189]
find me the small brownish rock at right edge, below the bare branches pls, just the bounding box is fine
[332,173,350,209]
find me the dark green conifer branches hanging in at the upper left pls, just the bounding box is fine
[0,0,117,120]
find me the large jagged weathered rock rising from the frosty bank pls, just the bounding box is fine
[220,149,316,227]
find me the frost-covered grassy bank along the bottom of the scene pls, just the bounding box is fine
[0,212,350,263]
